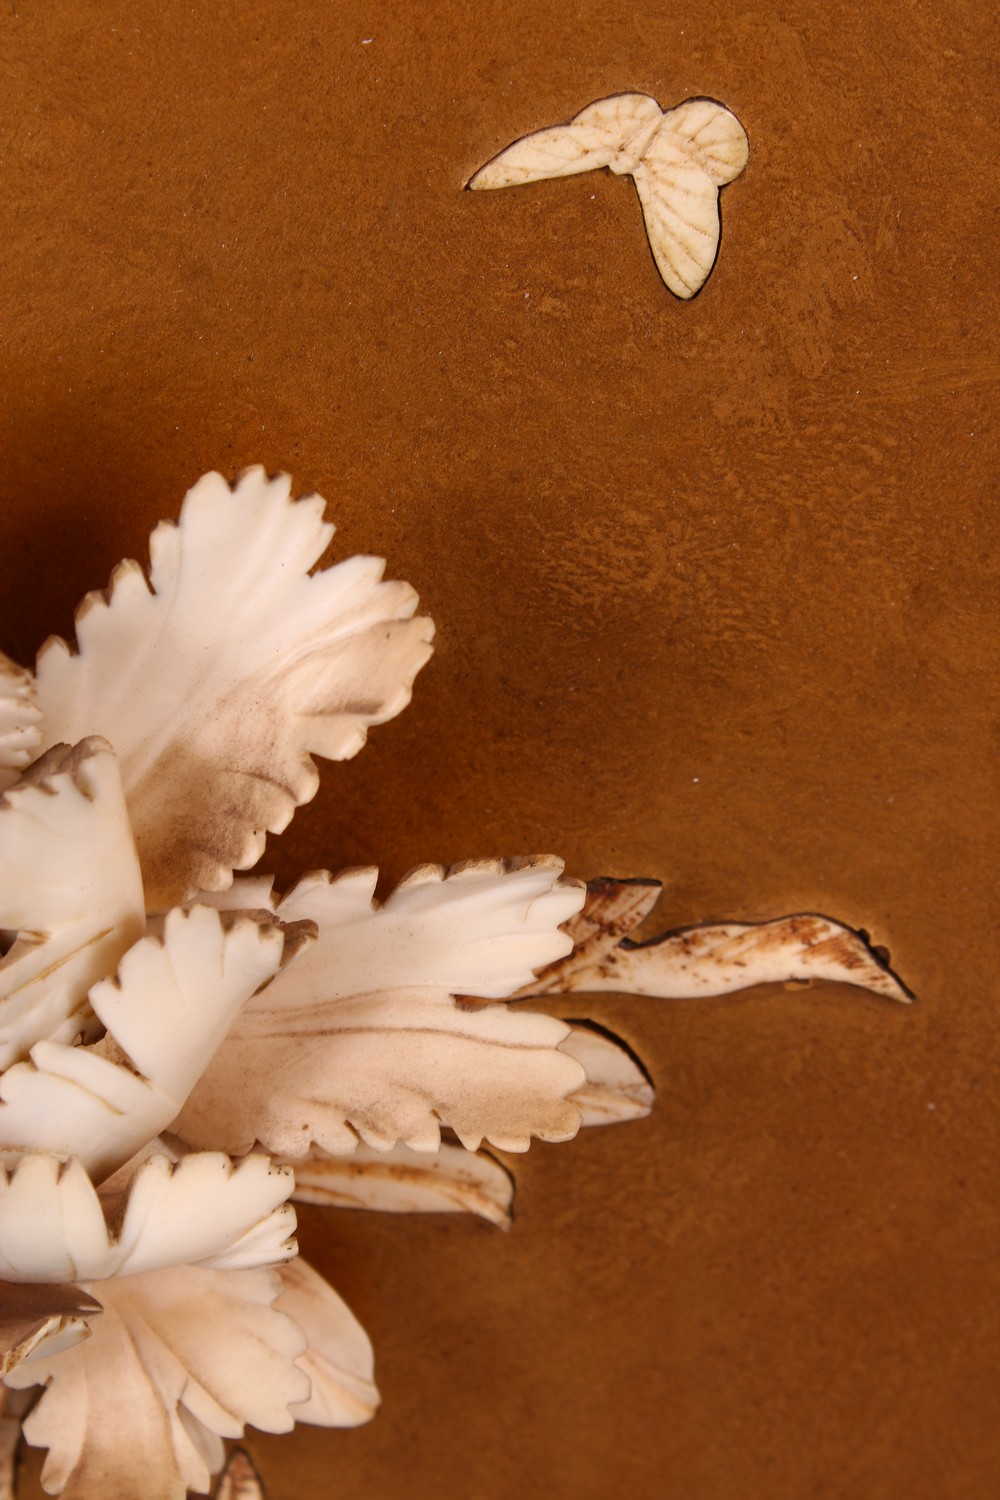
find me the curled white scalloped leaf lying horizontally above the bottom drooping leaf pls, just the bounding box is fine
[0,1152,295,1296]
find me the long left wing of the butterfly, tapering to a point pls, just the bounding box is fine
[468,95,663,189]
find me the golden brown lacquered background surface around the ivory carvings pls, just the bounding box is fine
[0,0,1000,1500]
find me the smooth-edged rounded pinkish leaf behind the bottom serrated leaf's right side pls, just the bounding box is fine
[274,1257,379,1427]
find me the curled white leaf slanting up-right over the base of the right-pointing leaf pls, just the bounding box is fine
[0,906,315,1181]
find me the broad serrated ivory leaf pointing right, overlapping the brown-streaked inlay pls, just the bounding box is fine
[172,858,583,1158]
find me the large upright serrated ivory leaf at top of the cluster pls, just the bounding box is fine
[37,468,433,911]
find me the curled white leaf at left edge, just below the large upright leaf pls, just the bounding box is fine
[0,738,145,1068]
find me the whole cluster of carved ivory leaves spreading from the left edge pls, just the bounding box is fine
[0,470,904,1500]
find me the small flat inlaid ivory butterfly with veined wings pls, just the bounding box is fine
[468,95,750,299]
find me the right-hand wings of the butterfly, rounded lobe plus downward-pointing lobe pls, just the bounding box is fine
[633,99,750,300]
